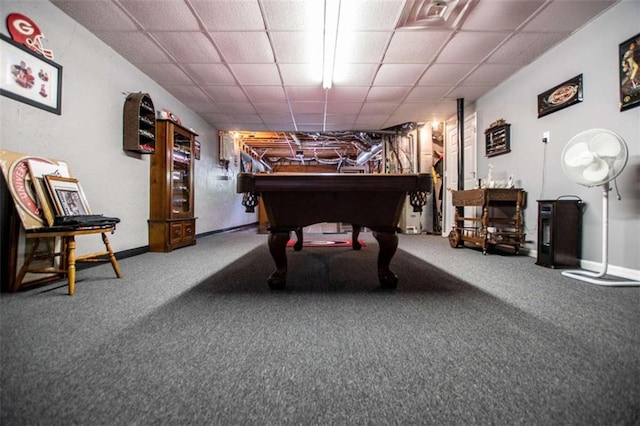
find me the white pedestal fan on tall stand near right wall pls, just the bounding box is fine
[562,129,640,286]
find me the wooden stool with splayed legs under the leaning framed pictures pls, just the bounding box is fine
[11,225,122,296]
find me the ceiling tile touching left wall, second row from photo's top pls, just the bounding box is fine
[95,32,169,64]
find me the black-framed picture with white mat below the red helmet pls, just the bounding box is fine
[0,34,62,115]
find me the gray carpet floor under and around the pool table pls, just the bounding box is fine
[0,230,640,425]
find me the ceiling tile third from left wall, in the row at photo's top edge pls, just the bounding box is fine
[189,0,265,31]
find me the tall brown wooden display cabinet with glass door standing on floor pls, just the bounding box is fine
[149,120,198,252]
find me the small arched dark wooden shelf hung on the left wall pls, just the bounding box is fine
[122,93,156,154]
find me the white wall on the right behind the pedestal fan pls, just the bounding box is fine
[477,0,640,270]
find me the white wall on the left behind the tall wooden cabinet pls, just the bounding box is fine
[0,0,256,252]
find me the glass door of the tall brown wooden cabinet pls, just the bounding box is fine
[171,130,191,217]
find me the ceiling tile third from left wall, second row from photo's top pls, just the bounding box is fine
[211,32,275,64]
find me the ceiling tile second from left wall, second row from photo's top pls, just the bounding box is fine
[151,32,221,63]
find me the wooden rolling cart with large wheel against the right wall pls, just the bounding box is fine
[449,188,526,254]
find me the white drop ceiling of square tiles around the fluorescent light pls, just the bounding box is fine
[51,0,617,166]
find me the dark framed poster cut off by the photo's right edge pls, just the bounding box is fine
[618,33,640,111]
